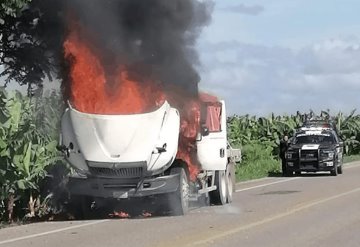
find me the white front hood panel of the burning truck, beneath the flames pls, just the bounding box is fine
[70,102,170,163]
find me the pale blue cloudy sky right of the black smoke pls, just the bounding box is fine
[198,0,360,115]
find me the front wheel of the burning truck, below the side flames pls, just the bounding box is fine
[169,167,190,215]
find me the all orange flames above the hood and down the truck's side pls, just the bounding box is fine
[64,26,200,180]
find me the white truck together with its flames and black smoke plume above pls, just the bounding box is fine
[51,0,241,215]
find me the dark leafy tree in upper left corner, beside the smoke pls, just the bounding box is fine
[0,0,62,96]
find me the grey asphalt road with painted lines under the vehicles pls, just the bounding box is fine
[0,163,360,247]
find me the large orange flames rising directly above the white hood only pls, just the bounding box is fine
[64,31,164,114]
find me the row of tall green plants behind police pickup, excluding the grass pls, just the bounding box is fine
[228,109,360,158]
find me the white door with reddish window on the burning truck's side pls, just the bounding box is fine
[197,101,227,170]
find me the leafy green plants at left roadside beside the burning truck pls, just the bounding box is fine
[0,89,61,221]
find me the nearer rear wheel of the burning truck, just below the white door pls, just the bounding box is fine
[210,171,227,205]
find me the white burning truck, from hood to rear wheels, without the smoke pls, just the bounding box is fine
[61,82,241,215]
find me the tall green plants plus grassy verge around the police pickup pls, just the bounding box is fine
[228,110,360,181]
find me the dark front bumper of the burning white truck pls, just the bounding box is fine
[69,174,180,199]
